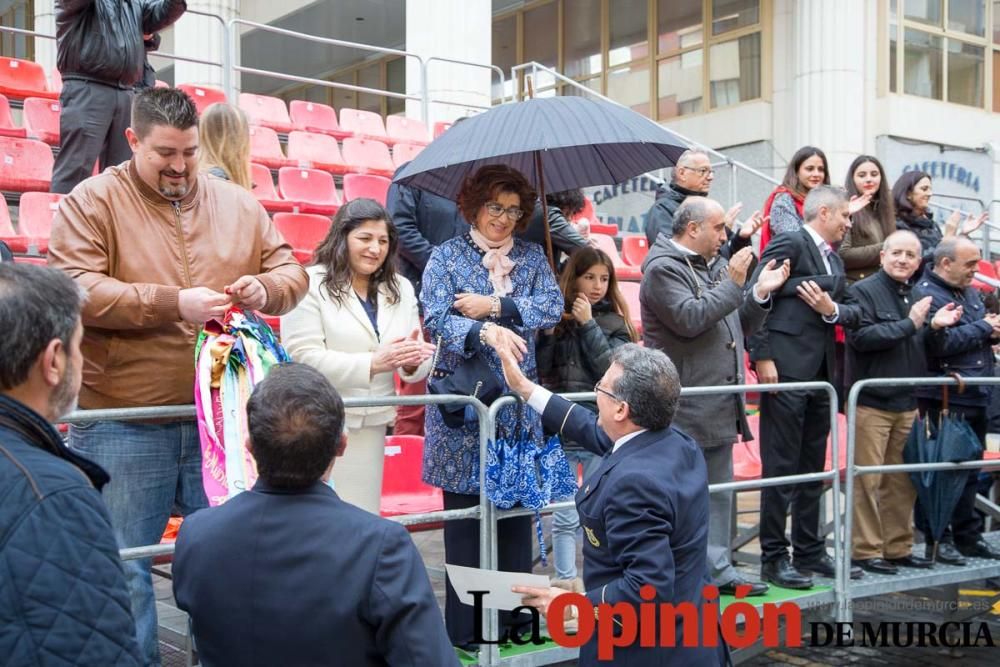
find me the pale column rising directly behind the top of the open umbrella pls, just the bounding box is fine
[405,0,488,127]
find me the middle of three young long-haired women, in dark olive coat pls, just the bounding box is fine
[837,155,896,282]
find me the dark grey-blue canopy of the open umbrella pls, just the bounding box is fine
[395,97,688,199]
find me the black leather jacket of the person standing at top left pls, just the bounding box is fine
[56,0,187,88]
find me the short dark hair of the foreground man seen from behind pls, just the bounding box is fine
[247,364,344,489]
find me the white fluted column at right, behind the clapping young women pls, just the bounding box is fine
[791,0,874,185]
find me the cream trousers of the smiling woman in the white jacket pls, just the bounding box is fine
[333,424,386,515]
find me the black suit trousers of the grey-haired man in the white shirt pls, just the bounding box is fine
[760,386,830,563]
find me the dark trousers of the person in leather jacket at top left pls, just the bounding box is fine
[51,79,132,194]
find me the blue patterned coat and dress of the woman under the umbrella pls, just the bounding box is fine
[420,234,563,495]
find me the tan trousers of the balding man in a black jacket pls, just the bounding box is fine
[851,405,917,560]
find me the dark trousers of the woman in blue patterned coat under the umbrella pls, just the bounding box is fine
[444,491,532,646]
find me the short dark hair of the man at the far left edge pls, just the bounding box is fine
[0,262,84,391]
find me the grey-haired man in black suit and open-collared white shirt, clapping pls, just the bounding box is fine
[750,186,862,588]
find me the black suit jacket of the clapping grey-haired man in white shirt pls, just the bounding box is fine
[750,229,861,381]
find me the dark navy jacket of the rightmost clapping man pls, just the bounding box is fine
[914,269,993,406]
